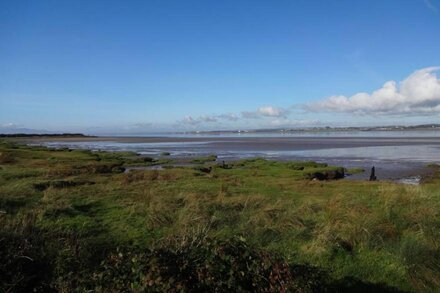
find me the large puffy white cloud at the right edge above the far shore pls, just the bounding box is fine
[304,67,440,115]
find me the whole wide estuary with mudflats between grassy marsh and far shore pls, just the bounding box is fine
[34,131,440,183]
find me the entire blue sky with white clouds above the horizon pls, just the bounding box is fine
[0,0,440,133]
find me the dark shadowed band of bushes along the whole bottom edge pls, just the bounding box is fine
[0,218,404,292]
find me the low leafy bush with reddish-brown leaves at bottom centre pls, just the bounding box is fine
[94,239,330,292]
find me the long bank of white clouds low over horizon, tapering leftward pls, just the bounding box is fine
[81,66,440,133]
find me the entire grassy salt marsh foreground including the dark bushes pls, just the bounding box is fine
[0,140,440,292]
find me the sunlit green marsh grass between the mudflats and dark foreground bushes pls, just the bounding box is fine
[0,141,440,292]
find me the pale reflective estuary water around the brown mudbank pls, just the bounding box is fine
[38,131,440,184]
